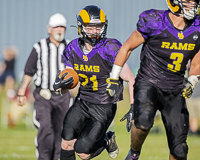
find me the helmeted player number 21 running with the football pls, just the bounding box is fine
[54,5,134,160]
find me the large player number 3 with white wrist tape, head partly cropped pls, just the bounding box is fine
[107,0,200,160]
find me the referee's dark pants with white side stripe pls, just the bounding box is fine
[33,88,71,160]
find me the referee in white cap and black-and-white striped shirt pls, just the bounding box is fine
[17,13,71,160]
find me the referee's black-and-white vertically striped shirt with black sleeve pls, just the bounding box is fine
[24,38,69,91]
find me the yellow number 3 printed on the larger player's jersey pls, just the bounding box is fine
[167,53,183,72]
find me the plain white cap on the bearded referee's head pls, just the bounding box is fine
[49,13,67,28]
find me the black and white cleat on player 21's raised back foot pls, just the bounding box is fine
[105,131,119,158]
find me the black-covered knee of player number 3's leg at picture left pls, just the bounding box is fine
[135,114,153,131]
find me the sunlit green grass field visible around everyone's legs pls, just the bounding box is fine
[0,88,200,160]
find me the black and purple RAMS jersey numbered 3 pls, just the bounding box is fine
[136,9,200,89]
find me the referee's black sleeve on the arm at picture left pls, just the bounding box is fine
[24,48,38,77]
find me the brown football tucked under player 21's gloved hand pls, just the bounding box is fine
[59,68,79,89]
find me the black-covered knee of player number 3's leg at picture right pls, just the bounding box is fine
[171,143,188,158]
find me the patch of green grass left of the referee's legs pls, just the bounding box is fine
[0,129,36,160]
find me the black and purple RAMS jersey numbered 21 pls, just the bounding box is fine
[63,38,123,104]
